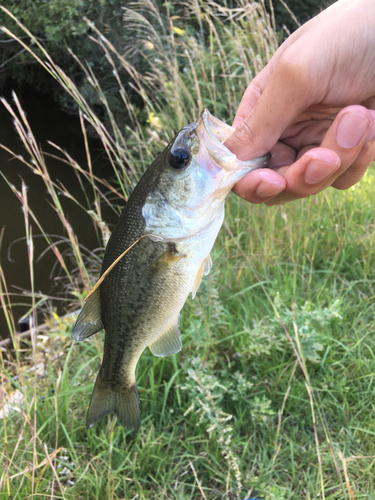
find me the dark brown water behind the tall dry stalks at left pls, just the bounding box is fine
[0,90,114,338]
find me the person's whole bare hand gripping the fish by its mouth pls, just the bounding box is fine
[225,0,375,205]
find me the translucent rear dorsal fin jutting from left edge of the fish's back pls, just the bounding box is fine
[72,288,103,340]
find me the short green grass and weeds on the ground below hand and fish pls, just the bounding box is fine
[1,173,375,500]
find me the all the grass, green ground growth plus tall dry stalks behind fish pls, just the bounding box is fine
[0,2,375,500]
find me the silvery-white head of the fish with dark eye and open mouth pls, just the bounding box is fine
[143,110,270,240]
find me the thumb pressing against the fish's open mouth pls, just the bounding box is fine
[225,60,309,160]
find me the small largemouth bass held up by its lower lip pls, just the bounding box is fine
[72,110,270,430]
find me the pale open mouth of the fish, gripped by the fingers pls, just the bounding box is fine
[197,109,271,172]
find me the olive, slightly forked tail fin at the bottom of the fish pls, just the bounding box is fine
[86,370,141,430]
